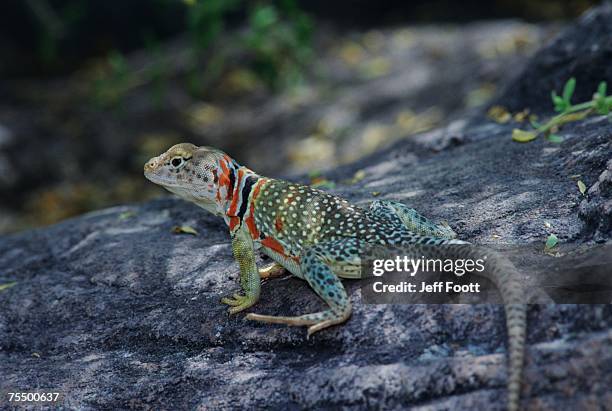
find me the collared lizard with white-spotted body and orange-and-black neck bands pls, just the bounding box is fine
[144,143,526,410]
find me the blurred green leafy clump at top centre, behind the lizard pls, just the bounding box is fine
[186,0,313,93]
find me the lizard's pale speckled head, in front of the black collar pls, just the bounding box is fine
[144,143,239,214]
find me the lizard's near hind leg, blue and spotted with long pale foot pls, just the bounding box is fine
[246,239,354,336]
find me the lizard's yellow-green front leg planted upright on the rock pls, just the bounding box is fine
[221,227,261,314]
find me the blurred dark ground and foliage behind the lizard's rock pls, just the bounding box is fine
[0,0,599,232]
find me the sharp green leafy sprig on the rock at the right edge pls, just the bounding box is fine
[512,77,612,143]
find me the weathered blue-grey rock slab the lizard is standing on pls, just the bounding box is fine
[0,6,612,410]
